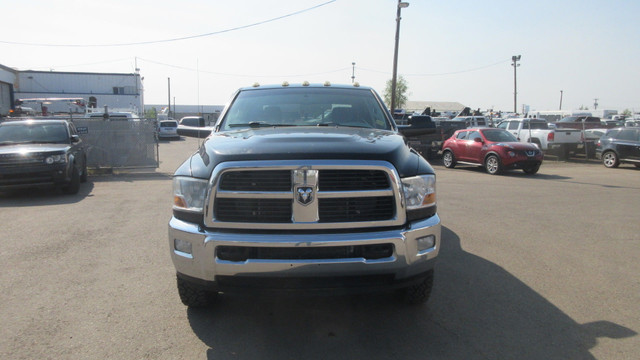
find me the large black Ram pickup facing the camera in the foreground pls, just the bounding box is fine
[169,83,441,307]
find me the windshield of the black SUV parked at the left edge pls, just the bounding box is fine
[0,123,69,145]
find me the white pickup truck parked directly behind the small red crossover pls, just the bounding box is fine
[497,119,584,158]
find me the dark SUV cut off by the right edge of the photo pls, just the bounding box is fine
[596,128,640,168]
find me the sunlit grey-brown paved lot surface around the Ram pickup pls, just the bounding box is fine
[0,139,640,359]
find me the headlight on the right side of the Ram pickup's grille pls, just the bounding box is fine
[402,175,436,220]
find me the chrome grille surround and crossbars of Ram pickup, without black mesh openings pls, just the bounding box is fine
[204,160,406,230]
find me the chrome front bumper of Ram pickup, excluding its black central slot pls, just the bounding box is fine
[169,214,441,291]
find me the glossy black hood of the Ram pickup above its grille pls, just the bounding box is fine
[176,127,434,178]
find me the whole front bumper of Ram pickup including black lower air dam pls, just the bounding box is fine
[169,214,441,292]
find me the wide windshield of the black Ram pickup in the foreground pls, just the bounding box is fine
[221,87,391,130]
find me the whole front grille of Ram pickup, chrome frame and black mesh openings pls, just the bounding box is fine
[205,162,404,230]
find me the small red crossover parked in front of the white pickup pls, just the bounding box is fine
[442,128,544,175]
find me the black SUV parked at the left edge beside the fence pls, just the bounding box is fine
[0,120,87,194]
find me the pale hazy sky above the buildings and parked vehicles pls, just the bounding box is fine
[0,0,640,111]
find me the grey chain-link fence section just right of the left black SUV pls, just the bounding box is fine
[73,119,159,169]
